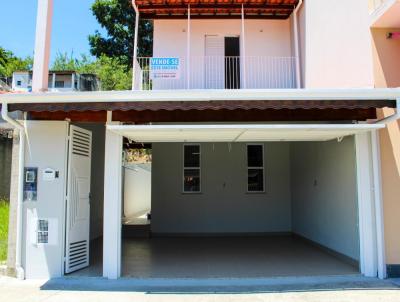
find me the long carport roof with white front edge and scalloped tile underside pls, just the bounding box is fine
[0,89,400,112]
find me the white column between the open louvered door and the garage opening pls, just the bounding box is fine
[103,123,122,279]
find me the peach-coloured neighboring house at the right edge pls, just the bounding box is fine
[371,0,400,276]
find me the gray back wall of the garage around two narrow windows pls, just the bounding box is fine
[152,143,291,233]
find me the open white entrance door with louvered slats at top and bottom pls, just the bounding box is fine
[65,126,92,273]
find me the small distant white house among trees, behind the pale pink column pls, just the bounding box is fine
[12,70,100,92]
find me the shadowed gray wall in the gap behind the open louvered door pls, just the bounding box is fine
[75,123,106,240]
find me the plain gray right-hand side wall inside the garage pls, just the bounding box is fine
[291,137,359,259]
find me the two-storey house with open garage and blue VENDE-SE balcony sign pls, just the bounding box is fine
[0,0,400,279]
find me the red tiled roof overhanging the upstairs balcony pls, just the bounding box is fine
[135,0,299,19]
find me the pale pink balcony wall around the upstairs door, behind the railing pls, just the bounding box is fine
[153,20,295,89]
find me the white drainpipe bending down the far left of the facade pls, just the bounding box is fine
[1,103,25,280]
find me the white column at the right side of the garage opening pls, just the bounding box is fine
[356,132,384,278]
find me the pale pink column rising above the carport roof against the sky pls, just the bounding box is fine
[32,0,53,92]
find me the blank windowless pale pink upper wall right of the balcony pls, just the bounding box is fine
[301,0,374,88]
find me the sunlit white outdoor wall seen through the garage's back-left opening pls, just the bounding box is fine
[124,163,151,217]
